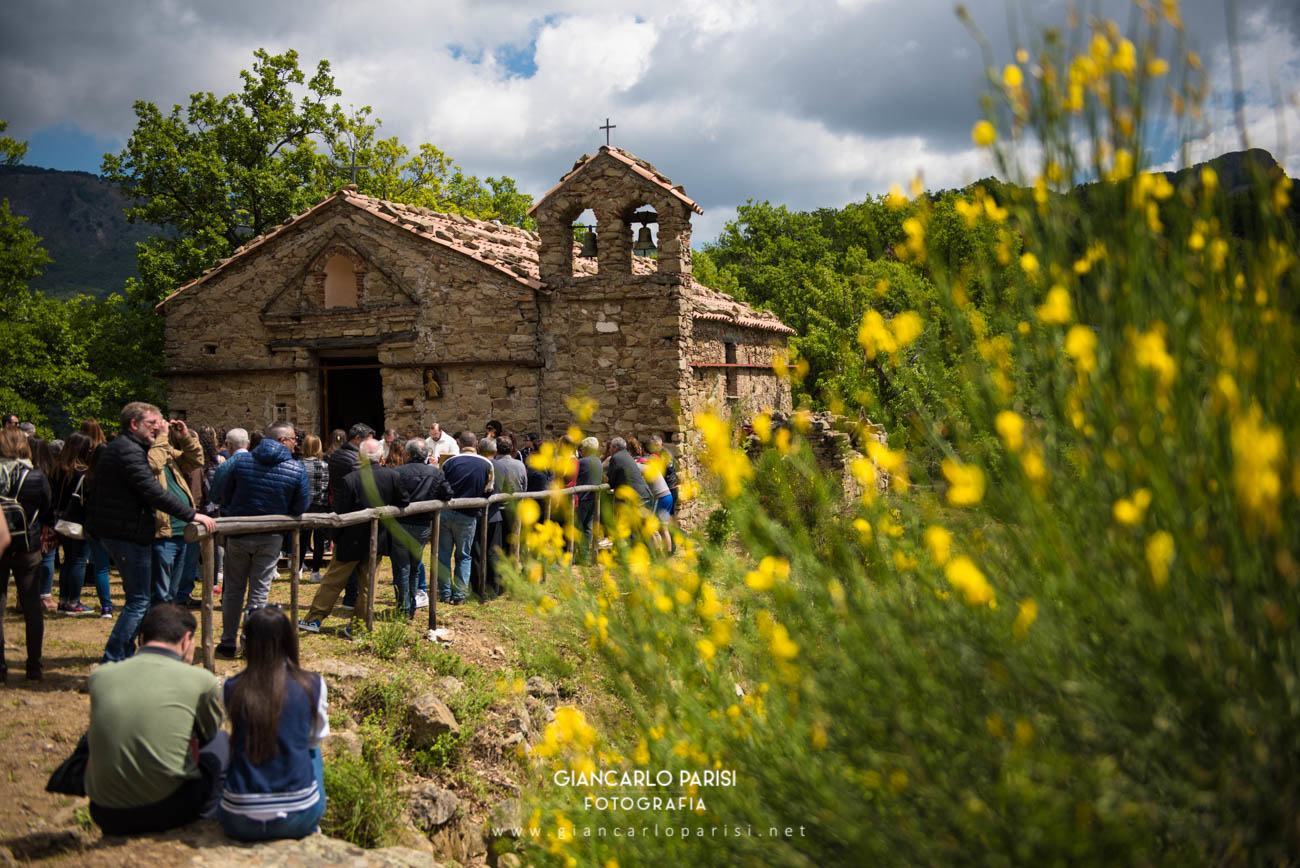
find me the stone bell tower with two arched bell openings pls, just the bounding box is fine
[529,146,703,442]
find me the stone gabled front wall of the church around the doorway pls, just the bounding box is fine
[164,201,541,433]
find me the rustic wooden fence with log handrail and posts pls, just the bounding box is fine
[185,485,610,672]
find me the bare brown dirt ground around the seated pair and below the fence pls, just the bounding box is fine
[0,565,590,865]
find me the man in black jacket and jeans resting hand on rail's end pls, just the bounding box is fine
[85,402,216,663]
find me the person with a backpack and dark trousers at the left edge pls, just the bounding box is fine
[0,428,53,683]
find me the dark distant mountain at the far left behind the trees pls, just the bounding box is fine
[0,166,159,298]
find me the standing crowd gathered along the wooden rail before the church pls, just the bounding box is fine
[0,402,677,680]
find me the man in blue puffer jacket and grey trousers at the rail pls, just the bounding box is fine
[211,422,311,659]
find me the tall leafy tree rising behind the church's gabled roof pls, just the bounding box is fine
[103,49,530,303]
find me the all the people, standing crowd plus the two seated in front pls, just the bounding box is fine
[0,402,676,841]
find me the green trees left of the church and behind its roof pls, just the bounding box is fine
[0,49,532,434]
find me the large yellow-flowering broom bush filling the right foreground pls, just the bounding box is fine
[506,8,1300,865]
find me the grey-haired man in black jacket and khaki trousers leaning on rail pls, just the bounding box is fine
[298,438,410,638]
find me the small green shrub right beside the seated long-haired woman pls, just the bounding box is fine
[321,721,406,847]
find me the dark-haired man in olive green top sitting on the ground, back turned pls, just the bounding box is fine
[86,603,230,836]
